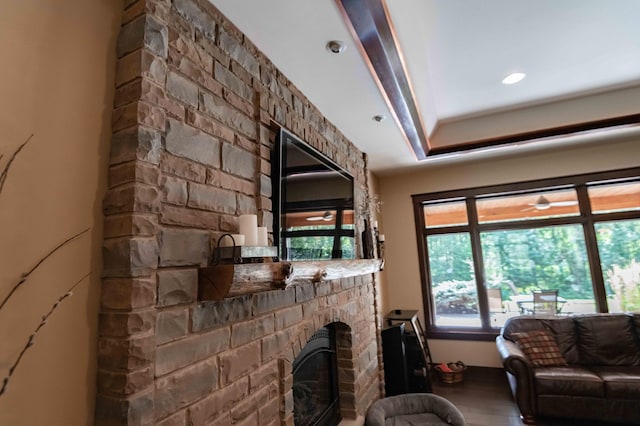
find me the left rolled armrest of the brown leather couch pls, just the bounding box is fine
[496,335,537,421]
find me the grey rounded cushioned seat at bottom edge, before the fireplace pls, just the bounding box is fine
[366,393,466,426]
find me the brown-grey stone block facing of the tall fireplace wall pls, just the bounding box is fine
[96,0,382,426]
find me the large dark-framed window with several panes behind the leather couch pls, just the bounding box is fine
[413,168,640,339]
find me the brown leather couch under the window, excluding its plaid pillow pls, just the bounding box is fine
[496,314,640,425]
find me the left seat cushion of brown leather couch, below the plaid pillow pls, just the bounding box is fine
[533,367,605,398]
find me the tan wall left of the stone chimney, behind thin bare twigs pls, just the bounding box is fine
[0,0,122,425]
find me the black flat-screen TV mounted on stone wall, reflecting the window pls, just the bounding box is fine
[272,128,356,260]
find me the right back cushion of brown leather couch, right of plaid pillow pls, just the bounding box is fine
[575,314,640,366]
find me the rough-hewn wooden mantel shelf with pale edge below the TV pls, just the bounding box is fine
[198,259,384,300]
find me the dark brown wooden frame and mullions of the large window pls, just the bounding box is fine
[411,167,640,340]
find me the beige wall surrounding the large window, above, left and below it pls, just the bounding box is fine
[379,132,640,367]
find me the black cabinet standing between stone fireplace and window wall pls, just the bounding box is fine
[382,310,431,396]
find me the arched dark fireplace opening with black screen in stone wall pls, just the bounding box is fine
[293,325,341,426]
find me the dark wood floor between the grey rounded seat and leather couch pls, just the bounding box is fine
[433,367,628,426]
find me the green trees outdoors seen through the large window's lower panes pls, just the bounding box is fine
[427,220,640,313]
